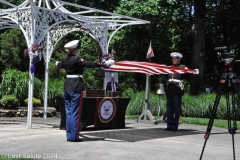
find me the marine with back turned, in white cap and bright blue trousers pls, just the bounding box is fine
[56,40,114,142]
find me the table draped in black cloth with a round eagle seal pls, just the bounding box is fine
[56,96,131,128]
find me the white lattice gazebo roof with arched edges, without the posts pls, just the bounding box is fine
[0,0,150,54]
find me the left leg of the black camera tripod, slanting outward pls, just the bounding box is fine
[200,83,224,160]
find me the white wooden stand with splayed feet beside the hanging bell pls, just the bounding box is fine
[137,74,163,124]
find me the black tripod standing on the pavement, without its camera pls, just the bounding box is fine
[200,62,240,160]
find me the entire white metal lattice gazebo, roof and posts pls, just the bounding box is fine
[0,0,150,128]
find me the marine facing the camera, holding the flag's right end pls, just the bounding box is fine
[164,52,187,131]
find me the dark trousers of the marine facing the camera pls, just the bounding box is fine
[167,96,182,129]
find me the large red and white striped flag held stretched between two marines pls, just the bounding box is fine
[104,61,195,75]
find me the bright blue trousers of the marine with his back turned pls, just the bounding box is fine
[64,92,82,140]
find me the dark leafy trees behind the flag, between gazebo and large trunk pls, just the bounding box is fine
[112,0,191,90]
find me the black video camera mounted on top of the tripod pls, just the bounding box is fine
[214,46,236,62]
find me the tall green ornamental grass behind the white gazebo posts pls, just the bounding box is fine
[0,69,64,107]
